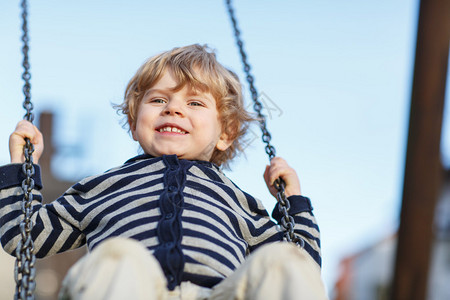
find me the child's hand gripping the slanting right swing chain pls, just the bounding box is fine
[264,157,300,197]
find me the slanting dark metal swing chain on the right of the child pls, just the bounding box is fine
[226,0,305,248]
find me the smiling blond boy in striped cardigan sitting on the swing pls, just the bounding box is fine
[0,45,326,299]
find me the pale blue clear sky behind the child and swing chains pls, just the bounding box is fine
[0,0,450,291]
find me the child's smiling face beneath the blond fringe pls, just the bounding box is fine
[131,70,231,161]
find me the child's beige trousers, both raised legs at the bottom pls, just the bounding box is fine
[60,238,328,300]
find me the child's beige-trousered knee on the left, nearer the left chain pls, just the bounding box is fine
[61,237,167,299]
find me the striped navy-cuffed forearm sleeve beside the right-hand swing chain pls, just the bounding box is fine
[272,196,322,266]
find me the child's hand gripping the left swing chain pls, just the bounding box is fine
[9,120,44,164]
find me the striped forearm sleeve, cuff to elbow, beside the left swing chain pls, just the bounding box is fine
[0,164,86,258]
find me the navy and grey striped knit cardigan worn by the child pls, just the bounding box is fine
[0,155,321,289]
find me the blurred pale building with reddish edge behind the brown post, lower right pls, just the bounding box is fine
[334,169,450,300]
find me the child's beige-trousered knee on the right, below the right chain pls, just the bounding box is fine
[212,242,327,300]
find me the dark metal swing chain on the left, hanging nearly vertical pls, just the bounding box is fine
[14,0,36,300]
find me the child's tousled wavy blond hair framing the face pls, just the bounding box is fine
[115,44,253,166]
